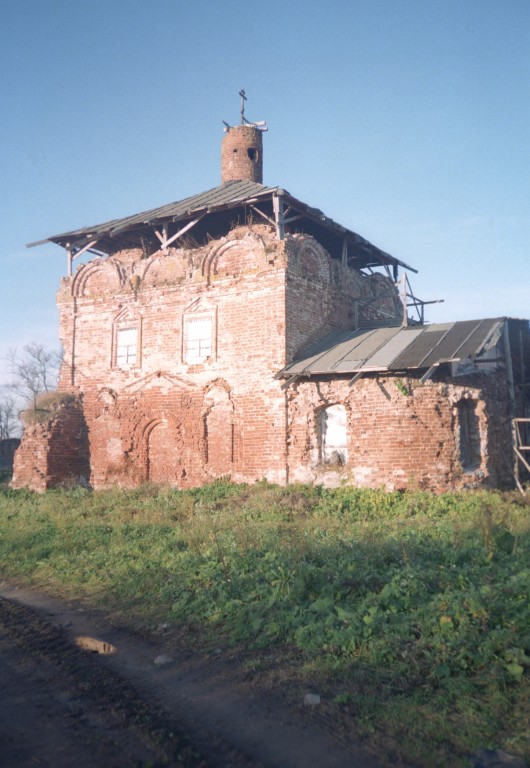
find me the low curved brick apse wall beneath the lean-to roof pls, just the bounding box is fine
[288,374,511,491]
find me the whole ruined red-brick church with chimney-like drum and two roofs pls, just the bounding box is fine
[13,121,530,490]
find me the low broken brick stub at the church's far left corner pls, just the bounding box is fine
[11,398,90,491]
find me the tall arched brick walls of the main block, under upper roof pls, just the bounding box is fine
[44,224,393,487]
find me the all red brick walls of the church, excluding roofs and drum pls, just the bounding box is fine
[15,225,509,490]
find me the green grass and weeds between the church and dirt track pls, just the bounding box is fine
[0,481,530,766]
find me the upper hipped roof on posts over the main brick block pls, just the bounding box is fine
[29,181,416,272]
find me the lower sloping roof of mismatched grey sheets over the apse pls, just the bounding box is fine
[278,318,505,378]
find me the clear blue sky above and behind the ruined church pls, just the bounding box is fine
[0,0,530,384]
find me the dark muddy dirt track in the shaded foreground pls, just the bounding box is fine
[0,584,376,768]
